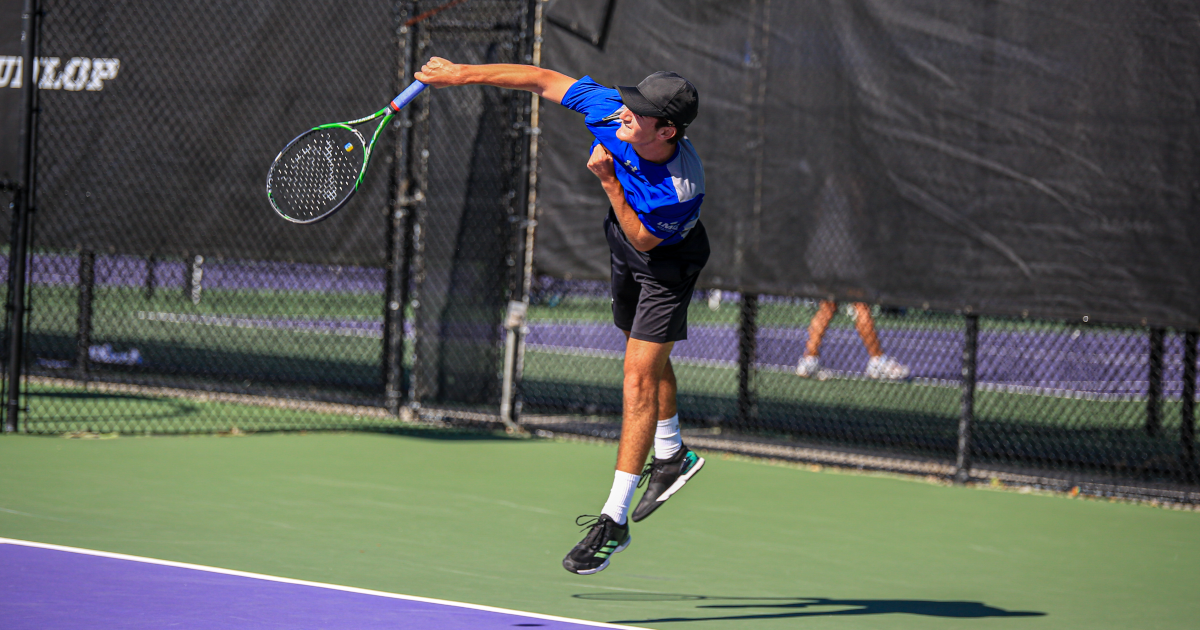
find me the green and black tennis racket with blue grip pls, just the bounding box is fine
[266,80,425,223]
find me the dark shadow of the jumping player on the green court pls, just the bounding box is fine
[571,593,1046,624]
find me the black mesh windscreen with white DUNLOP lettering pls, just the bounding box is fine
[27,0,401,265]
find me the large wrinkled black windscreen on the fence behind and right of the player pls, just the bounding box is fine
[536,0,1200,329]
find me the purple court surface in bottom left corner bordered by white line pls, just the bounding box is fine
[0,539,628,630]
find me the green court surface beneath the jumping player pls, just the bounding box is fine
[0,401,1200,629]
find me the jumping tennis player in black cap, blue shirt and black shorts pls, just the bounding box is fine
[414,56,708,575]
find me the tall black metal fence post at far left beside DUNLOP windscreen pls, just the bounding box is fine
[4,0,41,433]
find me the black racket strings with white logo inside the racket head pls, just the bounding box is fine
[270,127,364,220]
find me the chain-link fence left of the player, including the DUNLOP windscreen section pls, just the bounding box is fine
[4,0,530,432]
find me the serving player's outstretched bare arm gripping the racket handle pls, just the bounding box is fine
[413,56,575,103]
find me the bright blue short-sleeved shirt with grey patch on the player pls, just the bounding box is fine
[563,77,704,245]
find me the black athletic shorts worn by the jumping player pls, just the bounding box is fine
[604,208,708,343]
